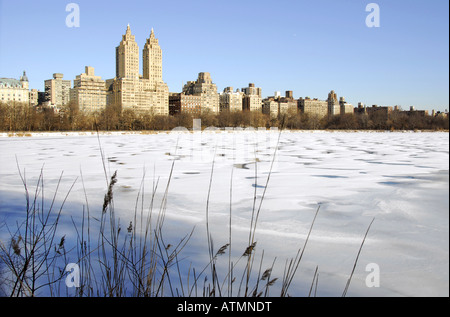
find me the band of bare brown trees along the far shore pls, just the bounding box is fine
[0,102,449,132]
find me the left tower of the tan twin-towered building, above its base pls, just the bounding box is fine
[116,24,139,79]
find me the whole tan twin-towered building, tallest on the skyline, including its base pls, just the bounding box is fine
[106,25,169,115]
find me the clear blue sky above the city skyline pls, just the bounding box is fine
[0,0,449,111]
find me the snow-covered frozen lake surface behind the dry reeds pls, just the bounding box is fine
[0,131,449,296]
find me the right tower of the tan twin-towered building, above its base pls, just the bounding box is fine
[142,28,162,83]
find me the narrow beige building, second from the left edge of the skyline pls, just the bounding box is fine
[44,73,71,108]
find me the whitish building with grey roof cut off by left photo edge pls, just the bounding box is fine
[0,71,30,103]
